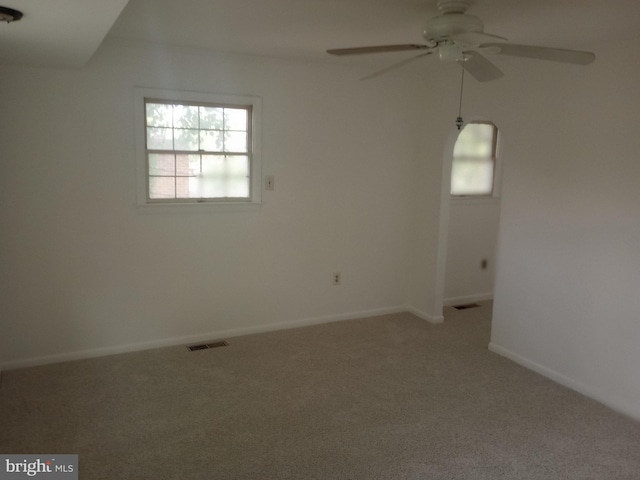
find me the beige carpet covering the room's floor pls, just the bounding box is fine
[0,304,640,480]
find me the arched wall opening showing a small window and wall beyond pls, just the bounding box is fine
[436,119,502,320]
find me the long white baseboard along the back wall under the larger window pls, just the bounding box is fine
[0,305,407,371]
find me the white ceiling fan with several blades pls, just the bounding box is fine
[327,0,596,82]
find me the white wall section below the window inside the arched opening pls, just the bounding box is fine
[444,198,500,305]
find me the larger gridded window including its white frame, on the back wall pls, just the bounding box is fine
[136,90,260,205]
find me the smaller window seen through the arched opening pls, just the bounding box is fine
[451,122,498,197]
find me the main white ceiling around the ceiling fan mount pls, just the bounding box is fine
[111,0,640,58]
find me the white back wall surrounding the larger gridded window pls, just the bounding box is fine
[0,41,440,367]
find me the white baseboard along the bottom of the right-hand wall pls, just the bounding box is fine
[489,342,640,420]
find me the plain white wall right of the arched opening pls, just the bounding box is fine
[491,40,640,418]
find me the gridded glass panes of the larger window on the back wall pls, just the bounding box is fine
[145,100,252,201]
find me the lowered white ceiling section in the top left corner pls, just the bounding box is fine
[0,0,128,68]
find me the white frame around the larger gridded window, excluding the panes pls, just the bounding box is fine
[134,88,262,210]
